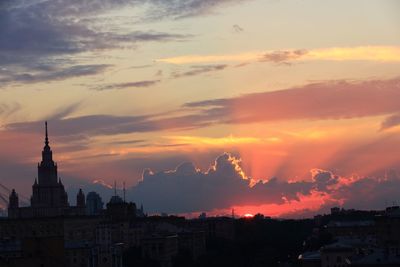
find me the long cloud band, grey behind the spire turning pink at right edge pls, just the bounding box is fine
[6,78,400,139]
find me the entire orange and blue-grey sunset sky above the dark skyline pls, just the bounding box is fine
[0,0,400,217]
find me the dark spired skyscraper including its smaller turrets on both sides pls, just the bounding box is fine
[8,122,86,218]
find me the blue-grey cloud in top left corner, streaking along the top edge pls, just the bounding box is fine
[0,0,240,64]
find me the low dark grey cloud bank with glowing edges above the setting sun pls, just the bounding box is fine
[121,153,400,217]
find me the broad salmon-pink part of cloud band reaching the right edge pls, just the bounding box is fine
[186,78,400,123]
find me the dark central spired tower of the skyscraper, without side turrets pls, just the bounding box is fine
[31,121,69,208]
